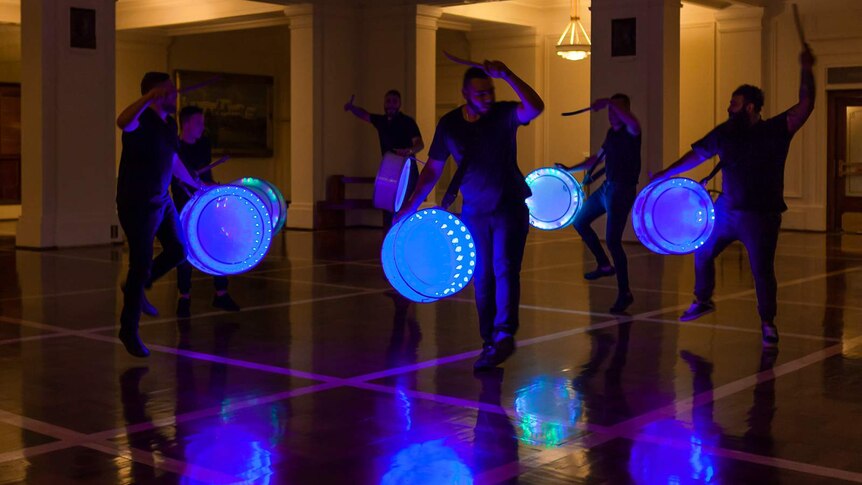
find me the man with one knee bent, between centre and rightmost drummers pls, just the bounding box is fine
[557,93,641,313]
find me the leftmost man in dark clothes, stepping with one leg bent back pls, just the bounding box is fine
[117,72,202,357]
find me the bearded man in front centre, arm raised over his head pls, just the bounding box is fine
[395,61,545,369]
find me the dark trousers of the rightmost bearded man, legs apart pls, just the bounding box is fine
[694,197,781,322]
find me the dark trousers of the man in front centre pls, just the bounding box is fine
[462,203,530,344]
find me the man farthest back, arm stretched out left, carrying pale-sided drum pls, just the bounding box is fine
[344,89,425,226]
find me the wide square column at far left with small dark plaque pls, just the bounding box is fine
[17,0,118,248]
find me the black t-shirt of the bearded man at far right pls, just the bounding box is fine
[691,112,793,212]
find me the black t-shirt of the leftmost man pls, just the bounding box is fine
[117,108,178,204]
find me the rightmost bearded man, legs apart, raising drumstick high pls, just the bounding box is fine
[653,45,815,347]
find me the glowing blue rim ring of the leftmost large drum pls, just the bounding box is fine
[181,184,272,275]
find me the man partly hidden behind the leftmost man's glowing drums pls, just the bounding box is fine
[171,106,240,318]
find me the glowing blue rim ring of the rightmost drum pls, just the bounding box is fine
[632,177,715,255]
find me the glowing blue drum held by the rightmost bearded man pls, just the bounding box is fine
[632,177,715,254]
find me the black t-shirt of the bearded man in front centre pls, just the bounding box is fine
[428,101,532,213]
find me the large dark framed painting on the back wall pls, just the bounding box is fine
[175,70,273,158]
